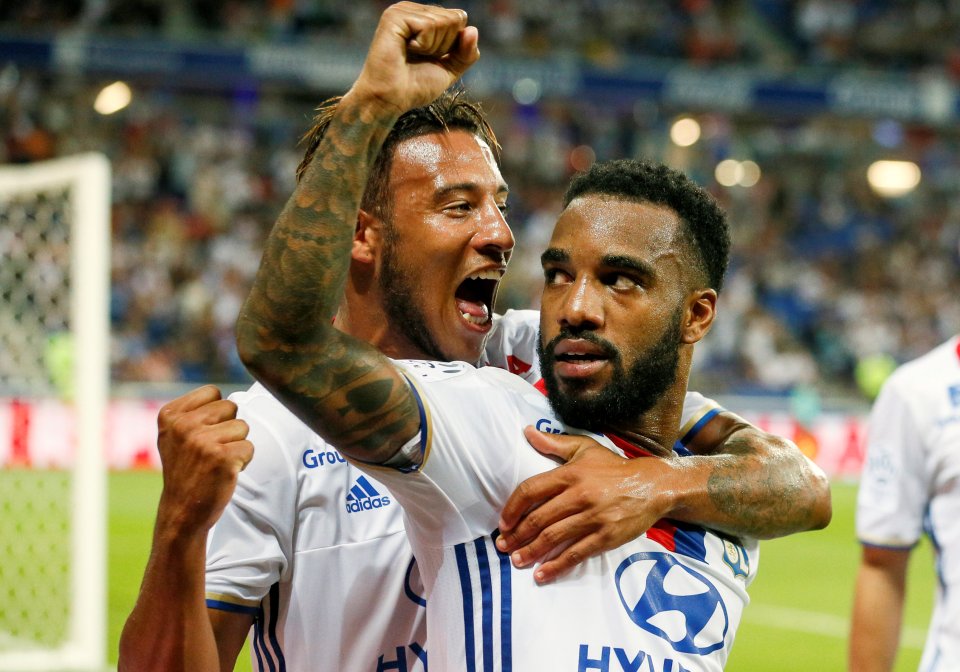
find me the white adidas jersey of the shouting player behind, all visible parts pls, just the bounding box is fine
[206,311,722,672]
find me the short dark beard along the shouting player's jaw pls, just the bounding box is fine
[379,227,449,362]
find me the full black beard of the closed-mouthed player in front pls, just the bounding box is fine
[537,306,683,433]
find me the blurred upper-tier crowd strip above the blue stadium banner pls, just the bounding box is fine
[0,0,960,76]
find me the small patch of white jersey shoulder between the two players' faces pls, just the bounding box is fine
[480,310,540,383]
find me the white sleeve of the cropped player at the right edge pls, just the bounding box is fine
[857,374,928,548]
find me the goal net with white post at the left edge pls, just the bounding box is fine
[0,154,110,671]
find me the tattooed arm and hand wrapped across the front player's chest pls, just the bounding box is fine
[497,413,831,582]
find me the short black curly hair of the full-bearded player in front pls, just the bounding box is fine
[563,159,730,292]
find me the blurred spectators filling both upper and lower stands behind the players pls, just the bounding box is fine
[0,0,960,395]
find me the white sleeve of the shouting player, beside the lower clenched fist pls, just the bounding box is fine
[206,393,304,614]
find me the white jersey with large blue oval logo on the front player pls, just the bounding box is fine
[362,361,758,671]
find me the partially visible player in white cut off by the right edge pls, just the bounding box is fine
[849,336,960,672]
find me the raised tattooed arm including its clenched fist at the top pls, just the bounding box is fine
[237,2,479,462]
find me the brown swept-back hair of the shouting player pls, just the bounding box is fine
[297,89,500,217]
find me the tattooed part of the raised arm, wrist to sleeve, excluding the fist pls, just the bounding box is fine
[237,96,419,461]
